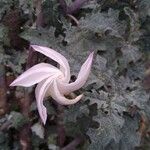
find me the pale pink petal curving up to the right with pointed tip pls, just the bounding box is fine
[59,52,94,94]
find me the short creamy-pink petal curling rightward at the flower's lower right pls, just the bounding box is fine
[51,80,83,105]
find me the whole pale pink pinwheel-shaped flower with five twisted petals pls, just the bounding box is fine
[10,45,93,124]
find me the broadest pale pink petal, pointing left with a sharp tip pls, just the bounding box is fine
[10,63,61,87]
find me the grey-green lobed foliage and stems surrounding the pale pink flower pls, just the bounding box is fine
[0,0,150,150]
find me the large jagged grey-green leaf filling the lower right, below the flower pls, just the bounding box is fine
[87,76,150,150]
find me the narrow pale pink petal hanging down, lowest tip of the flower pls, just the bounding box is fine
[35,77,53,125]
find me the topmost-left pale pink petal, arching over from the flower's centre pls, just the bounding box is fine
[31,45,70,82]
